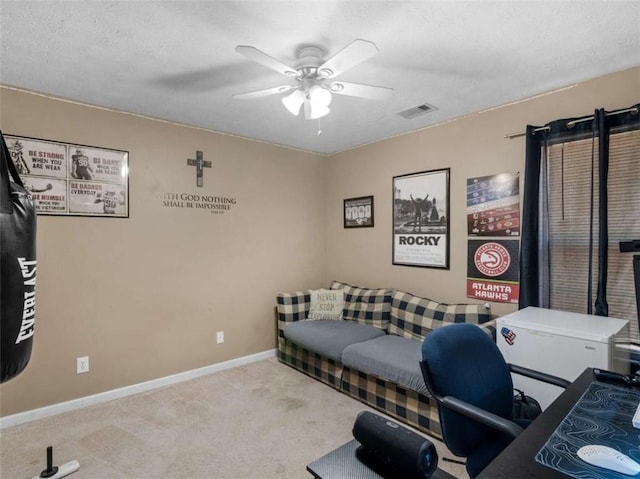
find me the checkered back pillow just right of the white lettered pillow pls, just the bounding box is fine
[331,281,392,331]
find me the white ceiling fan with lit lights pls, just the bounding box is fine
[232,39,393,120]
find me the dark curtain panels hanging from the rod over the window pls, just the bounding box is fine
[518,103,640,316]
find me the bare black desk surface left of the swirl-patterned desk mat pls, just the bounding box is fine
[477,368,593,479]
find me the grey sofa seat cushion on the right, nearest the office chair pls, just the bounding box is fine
[342,335,429,395]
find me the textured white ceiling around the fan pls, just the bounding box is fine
[0,0,640,154]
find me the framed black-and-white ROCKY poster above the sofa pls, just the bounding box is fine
[393,168,449,269]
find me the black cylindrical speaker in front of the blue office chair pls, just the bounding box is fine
[353,411,438,479]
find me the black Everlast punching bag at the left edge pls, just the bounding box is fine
[0,132,36,383]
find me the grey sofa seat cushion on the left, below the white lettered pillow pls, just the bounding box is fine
[284,319,384,361]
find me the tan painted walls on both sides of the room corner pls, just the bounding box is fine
[0,68,640,416]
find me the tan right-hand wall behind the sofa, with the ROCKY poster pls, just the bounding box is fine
[327,64,640,314]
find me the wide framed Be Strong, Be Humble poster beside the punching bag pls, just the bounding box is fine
[5,135,129,218]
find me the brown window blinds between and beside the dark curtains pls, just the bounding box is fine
[547,130,640,340]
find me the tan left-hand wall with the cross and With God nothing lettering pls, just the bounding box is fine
[0,88,327,416]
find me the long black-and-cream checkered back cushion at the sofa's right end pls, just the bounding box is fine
[389,291,491,340]
